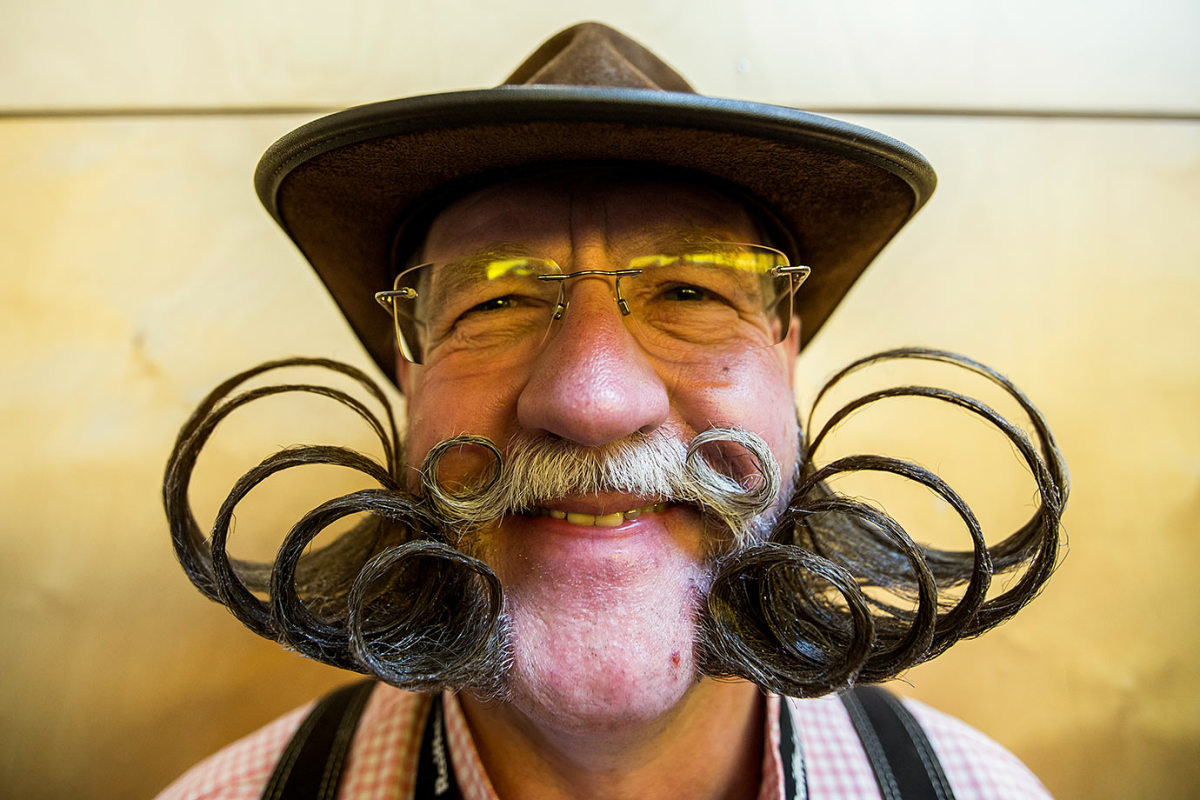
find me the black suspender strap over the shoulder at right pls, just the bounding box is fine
[841,686,954,800]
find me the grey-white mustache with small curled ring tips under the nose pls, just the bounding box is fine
[421,428,781,549]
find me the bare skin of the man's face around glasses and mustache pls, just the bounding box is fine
[400,169,798,729]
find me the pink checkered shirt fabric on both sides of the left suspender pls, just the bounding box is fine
[156,684,428,800]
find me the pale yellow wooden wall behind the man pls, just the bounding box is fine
[0,0,1200,798]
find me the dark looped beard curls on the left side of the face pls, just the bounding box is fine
[163,359,509,697]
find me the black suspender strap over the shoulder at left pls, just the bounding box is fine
[263,680,376,800]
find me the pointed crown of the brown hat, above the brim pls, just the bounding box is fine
[504,23,695,94]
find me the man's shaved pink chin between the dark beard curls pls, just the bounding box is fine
[475,510,710,734]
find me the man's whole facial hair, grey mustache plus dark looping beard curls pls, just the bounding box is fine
[163,349,1068,697]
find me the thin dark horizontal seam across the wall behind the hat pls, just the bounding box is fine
[0,106,1200,122]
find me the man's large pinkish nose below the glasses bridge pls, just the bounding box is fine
[517,278,670,447]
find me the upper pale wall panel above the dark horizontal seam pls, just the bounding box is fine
[0,0,1200,113]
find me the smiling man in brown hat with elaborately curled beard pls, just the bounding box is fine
[163,24,1066,798]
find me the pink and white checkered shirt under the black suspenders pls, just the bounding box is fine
[157,685,1050,800]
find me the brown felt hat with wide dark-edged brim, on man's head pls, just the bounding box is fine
[254,23,936,375]
